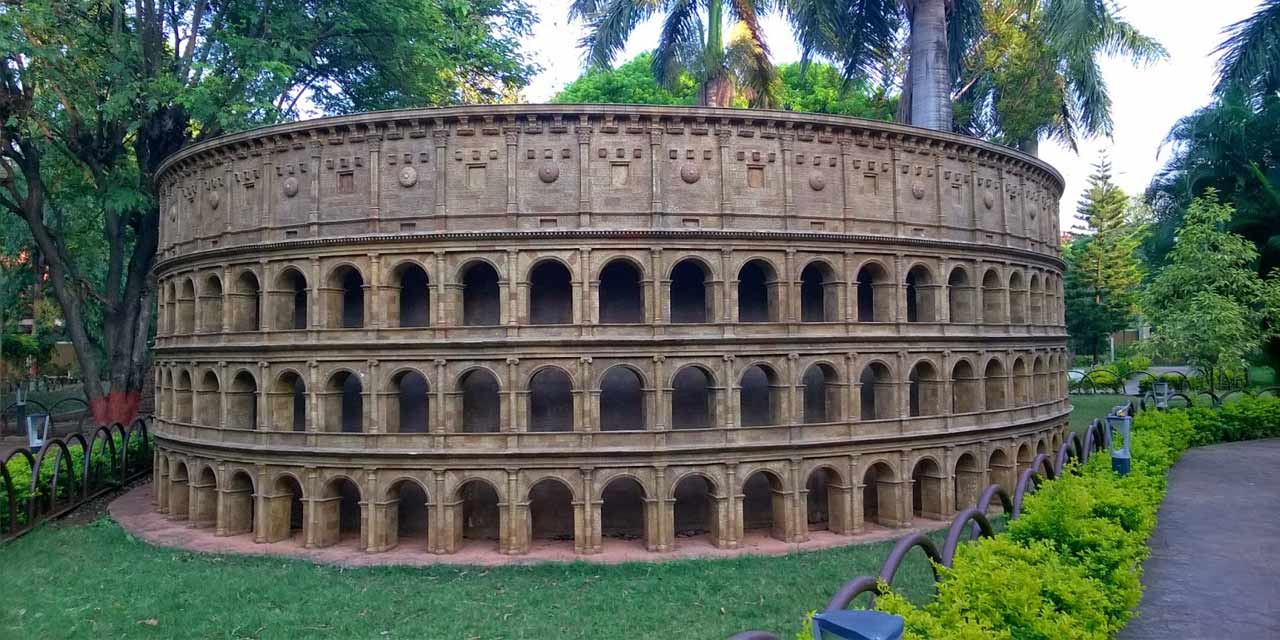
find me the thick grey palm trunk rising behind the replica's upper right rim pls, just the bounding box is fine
[905,0,951,131]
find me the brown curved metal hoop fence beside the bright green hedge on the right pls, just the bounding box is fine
[730,402,1138,640]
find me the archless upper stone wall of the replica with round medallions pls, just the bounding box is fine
[160,105,1062,259]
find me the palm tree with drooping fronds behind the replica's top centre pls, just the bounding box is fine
[570,0,777,108]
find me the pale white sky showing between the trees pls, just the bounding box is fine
[526,0,1258,228]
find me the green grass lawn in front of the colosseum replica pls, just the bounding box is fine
[0,518,933,640]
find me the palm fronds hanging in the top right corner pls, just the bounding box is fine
[1213,0,1280,96]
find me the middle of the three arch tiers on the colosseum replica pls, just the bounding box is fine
[156,351,1068,434]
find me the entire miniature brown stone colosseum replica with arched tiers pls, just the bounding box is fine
[147,105,1070,554]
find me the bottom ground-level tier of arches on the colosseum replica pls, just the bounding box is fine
[155,428,1065,554]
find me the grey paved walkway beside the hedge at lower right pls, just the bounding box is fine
[1120,439,1280,640]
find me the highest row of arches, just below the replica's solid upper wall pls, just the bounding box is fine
[159,253,1062,335]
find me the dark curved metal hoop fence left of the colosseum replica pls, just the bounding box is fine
[0,417,152,543]
